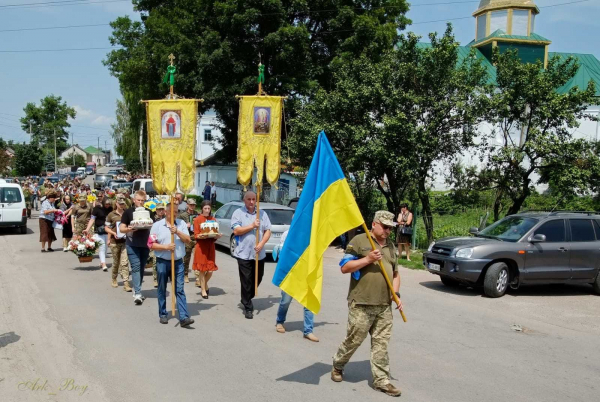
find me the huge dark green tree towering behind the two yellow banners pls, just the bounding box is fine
[105,0,409,160]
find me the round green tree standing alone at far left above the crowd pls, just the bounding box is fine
[20,95,76,153]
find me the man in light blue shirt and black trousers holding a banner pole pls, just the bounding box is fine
[231,191,271,319]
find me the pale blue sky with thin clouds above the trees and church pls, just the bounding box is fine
[0,0,600,155]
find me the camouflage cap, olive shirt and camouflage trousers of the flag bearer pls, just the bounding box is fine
[333,211,397,388]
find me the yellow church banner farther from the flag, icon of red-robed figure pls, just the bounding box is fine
[146,99,198,194]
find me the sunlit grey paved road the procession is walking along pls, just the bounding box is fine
[0,207,600,402]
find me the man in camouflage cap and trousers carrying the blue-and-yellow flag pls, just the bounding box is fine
[331,211,402,396]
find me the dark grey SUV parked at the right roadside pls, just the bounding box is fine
[423,212,600,297]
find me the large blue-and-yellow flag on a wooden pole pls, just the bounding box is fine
[273,131,363,314]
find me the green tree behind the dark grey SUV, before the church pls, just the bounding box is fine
[483,51,596,219]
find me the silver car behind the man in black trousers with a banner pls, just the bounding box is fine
[215,201,294,254]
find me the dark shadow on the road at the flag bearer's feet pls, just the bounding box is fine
[275,360,371,385]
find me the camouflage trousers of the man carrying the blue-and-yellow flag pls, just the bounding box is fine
[333,302,392,387]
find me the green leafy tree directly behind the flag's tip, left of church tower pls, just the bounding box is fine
[290,26,487,243]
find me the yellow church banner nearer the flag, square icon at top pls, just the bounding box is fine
[237,95,284,186]
